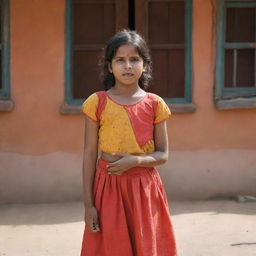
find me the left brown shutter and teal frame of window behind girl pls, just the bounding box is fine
[65,0,117,106]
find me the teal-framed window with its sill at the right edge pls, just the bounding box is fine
[215,0,256,108]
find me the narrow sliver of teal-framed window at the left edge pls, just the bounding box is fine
[0,0,10,100]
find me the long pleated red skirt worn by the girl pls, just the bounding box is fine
[81,159,177,256]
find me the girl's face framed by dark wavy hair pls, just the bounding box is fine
[109,44,144,85]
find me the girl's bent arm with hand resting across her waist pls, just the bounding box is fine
[108,121,168,175]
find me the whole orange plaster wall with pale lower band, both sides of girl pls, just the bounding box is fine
[0,0,256,202]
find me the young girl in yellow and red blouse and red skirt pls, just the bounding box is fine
[81,30,177,256]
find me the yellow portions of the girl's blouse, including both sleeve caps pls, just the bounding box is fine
[82,93,171,155]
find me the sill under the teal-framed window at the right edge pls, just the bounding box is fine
[215,97,256,109]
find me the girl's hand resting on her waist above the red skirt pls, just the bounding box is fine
[107,153,138,175]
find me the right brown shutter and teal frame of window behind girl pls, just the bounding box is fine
[141,0,192,103]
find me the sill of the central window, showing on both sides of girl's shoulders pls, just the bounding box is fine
[59,103,196,114]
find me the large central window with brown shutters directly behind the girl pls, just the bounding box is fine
[65,0,192,110]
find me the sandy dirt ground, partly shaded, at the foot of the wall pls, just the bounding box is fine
[0,200,256,256]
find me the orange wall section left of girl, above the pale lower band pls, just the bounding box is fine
[0,0,83,155]
